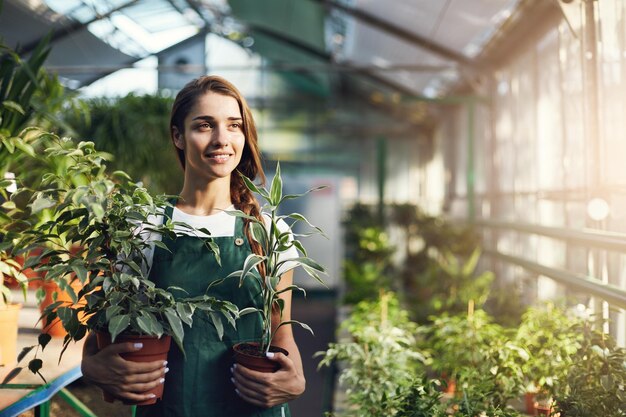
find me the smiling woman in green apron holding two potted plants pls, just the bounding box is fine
[82,76,305,417]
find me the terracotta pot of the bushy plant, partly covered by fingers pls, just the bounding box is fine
[96,332,172,405]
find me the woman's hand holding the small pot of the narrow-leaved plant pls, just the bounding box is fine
[231,353,306,408]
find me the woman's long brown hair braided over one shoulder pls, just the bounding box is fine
[170,75,265,264]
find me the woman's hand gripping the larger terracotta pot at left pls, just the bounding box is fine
[81,334,169,401]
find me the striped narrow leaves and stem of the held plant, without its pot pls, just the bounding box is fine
[225,164,326,352]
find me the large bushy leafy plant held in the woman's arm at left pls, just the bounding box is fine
[4,134,238,403]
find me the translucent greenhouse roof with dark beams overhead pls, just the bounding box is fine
[0,0,523,97]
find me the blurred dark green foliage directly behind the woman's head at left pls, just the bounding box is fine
[64,93,182,193]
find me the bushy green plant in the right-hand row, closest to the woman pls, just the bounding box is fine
[316,292,426,417]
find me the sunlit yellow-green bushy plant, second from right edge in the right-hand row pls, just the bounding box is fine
[516,302,583,396]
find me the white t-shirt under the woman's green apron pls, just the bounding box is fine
[138,205,299,275]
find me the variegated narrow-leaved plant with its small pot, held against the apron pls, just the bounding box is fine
[225,164,325,372]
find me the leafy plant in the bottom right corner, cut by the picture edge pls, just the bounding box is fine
[556,322,626,417]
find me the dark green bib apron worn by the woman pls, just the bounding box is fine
[137,207,290,417]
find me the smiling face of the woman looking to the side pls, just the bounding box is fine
[174,92,246,181]
